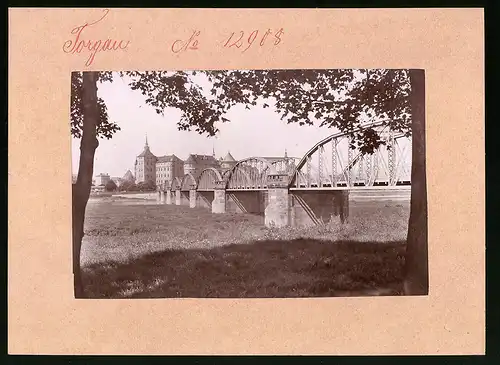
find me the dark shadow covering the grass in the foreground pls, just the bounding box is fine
[84,239,406,298]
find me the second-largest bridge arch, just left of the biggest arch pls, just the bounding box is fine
[225,157,277,189]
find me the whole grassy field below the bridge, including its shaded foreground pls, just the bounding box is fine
[82,198,409,298]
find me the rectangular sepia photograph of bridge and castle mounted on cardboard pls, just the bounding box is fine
[69,69,429,299]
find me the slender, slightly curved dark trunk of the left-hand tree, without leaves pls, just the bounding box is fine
[72,71,99,298]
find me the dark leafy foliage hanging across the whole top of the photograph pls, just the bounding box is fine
[71,69,411,153]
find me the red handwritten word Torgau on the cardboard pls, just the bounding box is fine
[63,9,130,66]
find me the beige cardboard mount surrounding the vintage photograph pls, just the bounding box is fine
[8,9,485,354]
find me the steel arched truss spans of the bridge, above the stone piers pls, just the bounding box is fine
[162,121,411,192]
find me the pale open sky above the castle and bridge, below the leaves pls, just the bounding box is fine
[72,72,344,177]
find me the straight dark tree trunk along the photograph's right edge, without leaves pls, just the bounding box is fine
[404,70,429,295]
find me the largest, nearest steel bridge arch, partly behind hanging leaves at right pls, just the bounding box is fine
[289,120,411,188]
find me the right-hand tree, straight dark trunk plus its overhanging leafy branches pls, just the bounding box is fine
[208,70,429,295]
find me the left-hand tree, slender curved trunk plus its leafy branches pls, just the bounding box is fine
[70,71,222,298]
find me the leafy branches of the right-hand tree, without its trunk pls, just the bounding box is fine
[203,70,411,153]
